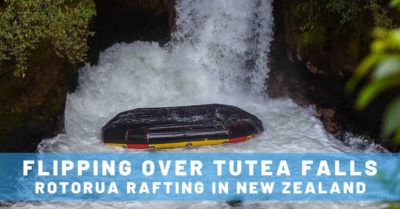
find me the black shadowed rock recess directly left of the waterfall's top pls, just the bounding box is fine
[89,0,175,63]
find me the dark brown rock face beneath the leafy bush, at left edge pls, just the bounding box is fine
[0,44,72,152]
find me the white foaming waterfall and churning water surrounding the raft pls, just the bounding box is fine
[7,0,383,209]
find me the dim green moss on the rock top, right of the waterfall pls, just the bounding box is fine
[285,0,398,59]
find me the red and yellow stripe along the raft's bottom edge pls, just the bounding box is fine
[105,135,254,149]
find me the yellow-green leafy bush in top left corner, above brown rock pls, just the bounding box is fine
[0,0,95,76]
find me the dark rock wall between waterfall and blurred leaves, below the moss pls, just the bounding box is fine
[267,0,397,150]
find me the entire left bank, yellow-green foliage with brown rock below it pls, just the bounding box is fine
[0,0,95,151]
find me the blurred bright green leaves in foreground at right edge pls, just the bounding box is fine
[347,29,400,143]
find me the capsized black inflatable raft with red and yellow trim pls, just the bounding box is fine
[102,104,263,149]
